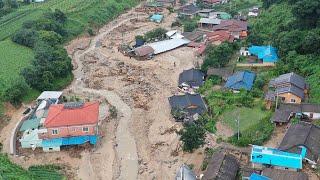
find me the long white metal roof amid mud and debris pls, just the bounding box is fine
[147,38,190,54]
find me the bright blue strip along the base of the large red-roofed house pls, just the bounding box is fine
[42,136,98,147]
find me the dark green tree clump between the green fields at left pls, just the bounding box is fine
[3,10,72,104]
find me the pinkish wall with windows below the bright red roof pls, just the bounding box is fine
[40,124,98,139]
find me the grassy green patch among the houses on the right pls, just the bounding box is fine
[221,107,267,131]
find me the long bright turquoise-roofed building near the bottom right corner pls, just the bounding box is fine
[250,145,307,170]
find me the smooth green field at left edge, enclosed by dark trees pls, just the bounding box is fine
[0,40,33,92]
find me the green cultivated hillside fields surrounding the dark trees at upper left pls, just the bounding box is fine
[0,0,136,101]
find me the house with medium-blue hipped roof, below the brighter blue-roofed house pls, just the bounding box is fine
[224,71,256,91]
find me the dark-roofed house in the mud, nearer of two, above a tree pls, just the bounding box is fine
[169,93,207,122]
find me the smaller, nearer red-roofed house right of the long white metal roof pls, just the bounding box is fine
[206,30,234,45]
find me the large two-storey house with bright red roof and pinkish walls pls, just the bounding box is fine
[40,102,99,139]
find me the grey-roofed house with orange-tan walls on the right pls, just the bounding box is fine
[265,73,309,108]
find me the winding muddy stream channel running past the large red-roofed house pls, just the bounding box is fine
[69,12,148,180]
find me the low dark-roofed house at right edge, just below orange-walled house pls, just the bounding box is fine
[271,103,320,125]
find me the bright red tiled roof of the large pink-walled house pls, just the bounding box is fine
[44,102,99,128]
